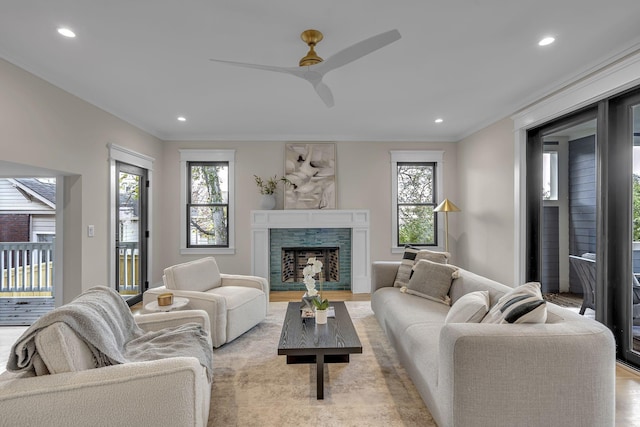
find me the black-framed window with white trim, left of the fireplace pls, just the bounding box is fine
[180,150,235,254]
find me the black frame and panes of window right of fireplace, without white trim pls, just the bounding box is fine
[396,162,438,247]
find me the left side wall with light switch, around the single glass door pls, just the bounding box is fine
[0,60,163,301]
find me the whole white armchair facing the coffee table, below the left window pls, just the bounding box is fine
[143,257,269,347]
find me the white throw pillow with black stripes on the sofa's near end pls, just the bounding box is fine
[481,282,547,323]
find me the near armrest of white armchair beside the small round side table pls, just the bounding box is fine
[142,286,227,347]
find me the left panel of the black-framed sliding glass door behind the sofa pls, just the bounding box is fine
[526,108,598,318]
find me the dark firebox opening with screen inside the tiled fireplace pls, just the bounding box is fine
[282,247,340,283]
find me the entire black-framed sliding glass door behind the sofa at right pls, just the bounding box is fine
[526,88,640,367]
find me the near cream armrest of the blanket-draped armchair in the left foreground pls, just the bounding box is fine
[0,357,211,427]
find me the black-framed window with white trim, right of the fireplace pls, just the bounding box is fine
[391,151,443,252]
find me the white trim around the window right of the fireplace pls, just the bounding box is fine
[389,150,444,254]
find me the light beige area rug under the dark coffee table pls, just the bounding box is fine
[209,301,435,427]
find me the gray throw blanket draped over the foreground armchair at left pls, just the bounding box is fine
[7,286,213,380]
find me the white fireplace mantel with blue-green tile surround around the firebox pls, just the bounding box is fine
[251,210,371,293]
